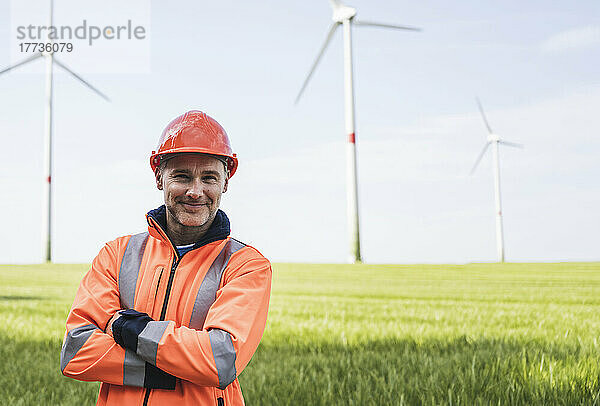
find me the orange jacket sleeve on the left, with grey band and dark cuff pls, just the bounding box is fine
[60,240,175,389]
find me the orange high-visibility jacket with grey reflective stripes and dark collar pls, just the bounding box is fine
[61,206,271,406]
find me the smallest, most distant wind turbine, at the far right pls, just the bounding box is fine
[471,98,523,262]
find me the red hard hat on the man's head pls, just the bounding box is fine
[150,110,238,177]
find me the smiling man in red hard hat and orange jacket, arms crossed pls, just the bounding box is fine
[61,111,271,406]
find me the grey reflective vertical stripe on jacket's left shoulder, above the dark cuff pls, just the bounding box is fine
[119,232,148,309]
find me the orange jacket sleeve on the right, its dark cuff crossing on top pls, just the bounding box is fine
[113,251,272,389]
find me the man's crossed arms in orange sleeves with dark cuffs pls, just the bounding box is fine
[61,240,271,389]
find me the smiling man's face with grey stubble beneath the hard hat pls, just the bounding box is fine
[156,153,227,232]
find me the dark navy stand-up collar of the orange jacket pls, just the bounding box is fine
[146,204,231,249]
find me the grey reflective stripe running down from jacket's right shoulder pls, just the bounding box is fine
[190,239,246,330]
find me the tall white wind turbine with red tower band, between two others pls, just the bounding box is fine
[296,0,420,263]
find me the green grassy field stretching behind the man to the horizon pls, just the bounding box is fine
[0,263,600,405]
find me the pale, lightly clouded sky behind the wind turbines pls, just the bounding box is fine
[0,0,600,263]
